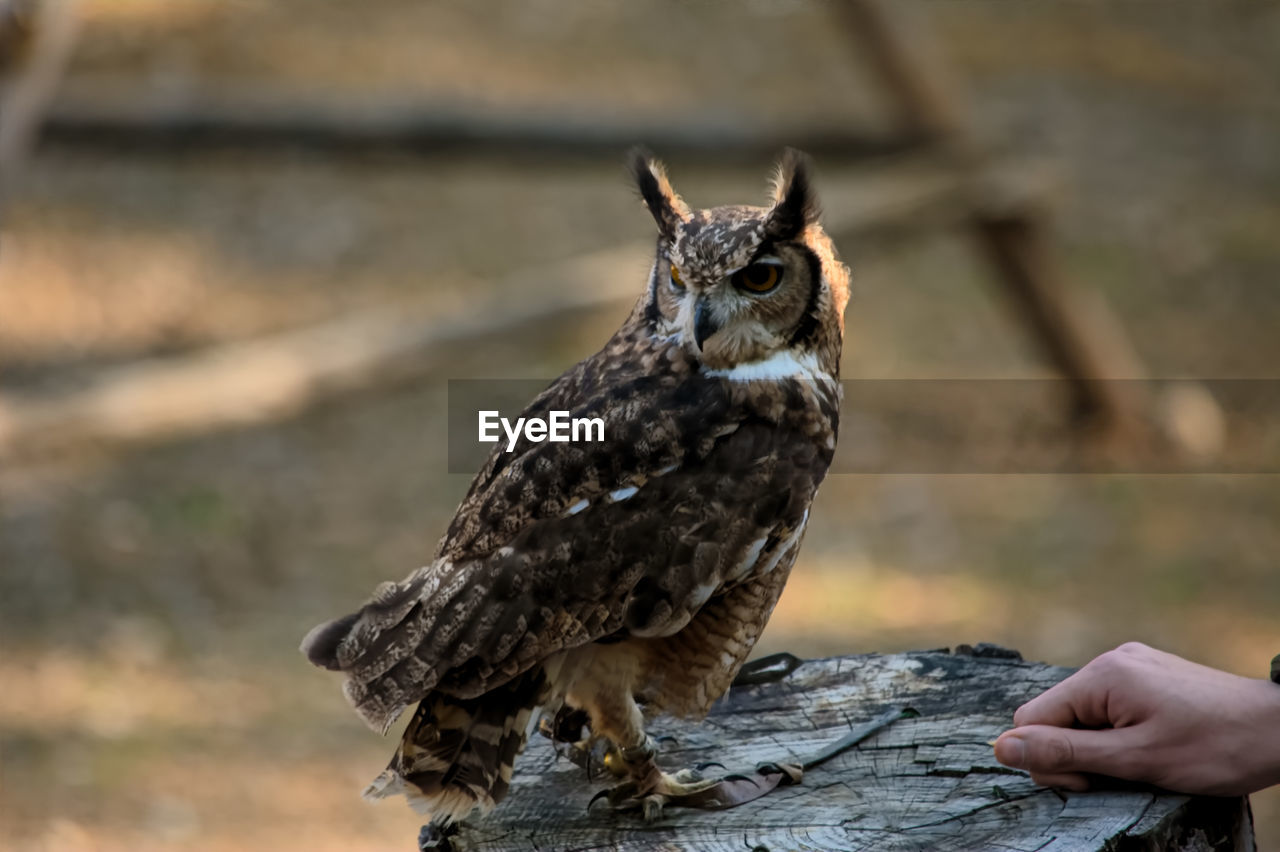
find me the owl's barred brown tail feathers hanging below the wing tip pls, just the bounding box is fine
[364,667,548,825]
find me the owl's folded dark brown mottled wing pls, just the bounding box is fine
[303,355,831,729]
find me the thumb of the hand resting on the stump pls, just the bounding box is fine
[996,725,1138,779]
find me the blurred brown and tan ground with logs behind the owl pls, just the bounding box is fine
[0,0,1280,852]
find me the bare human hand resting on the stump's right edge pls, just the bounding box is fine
[996,642,1280,796]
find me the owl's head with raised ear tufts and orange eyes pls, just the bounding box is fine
[631,150,849,376]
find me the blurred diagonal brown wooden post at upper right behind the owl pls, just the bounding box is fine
[838,0,1149,438]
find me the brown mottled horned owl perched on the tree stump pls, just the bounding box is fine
[302,151,849,825]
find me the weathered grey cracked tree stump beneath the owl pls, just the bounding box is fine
[444,645,1254,852]
